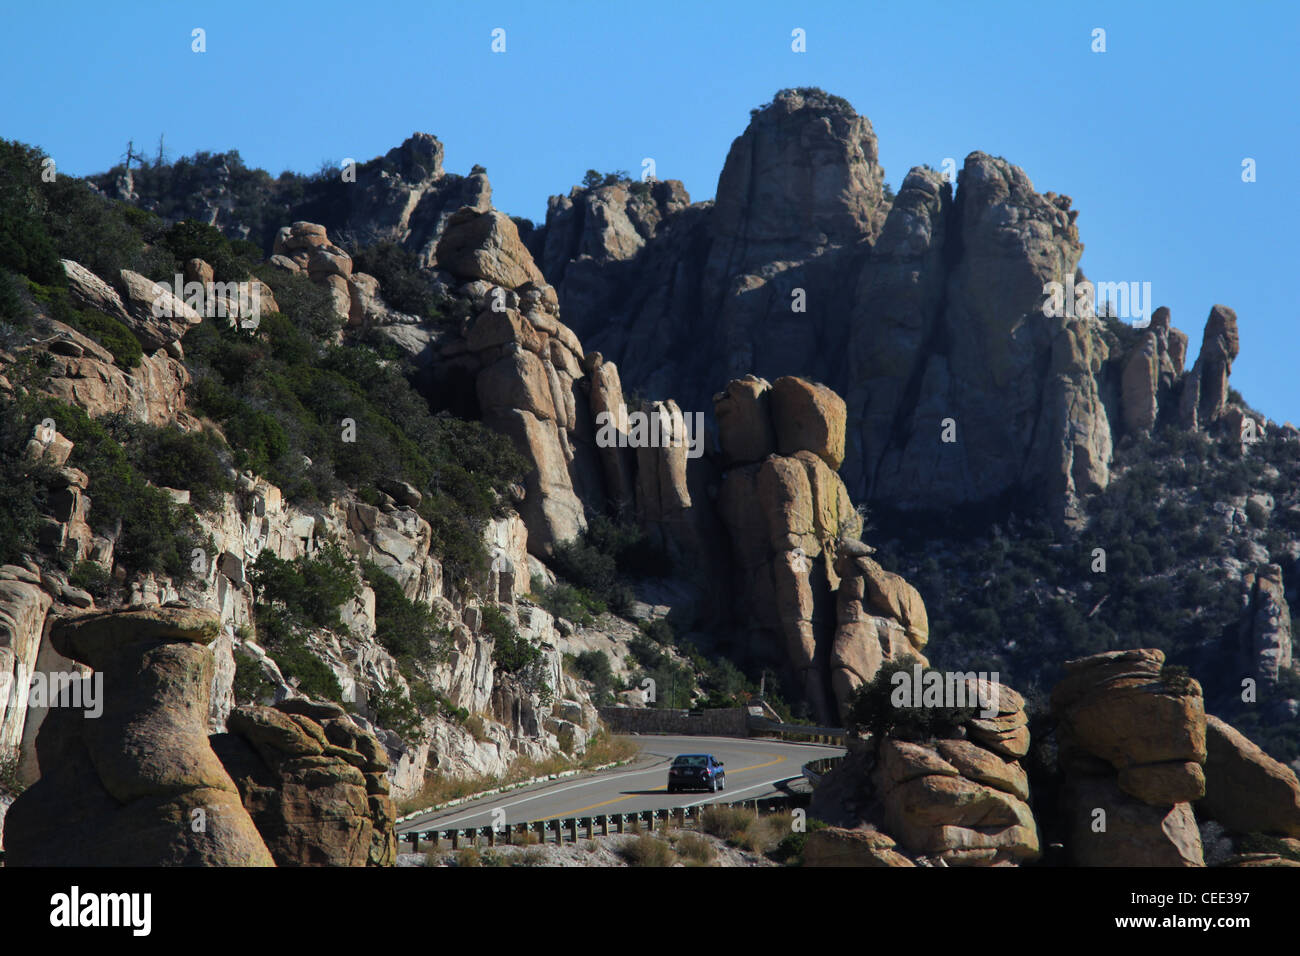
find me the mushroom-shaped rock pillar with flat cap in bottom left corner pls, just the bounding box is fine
[5,607,274,866]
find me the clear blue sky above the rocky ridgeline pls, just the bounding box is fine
[0,0,1300,423]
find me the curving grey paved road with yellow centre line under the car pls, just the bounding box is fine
[398,735,845,832]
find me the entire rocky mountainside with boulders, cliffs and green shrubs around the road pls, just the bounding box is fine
[0,90,1300,865]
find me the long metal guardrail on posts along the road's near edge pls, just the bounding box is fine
[398,796,793,853]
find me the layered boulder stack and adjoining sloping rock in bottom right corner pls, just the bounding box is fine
[1052,649,1300,866]
